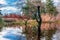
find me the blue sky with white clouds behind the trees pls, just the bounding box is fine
[0,0,59,14]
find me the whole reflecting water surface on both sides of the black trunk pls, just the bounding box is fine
[0,23,60,40]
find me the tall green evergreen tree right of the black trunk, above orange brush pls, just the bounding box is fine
[46,0,58,16]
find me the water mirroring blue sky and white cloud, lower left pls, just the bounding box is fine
[0,27,26,40]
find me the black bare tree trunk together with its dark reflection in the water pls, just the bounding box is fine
[37,6,42,40]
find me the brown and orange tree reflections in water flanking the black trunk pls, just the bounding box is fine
[23,22,58,40]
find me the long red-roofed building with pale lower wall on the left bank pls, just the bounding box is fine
[3,14,29,22]
